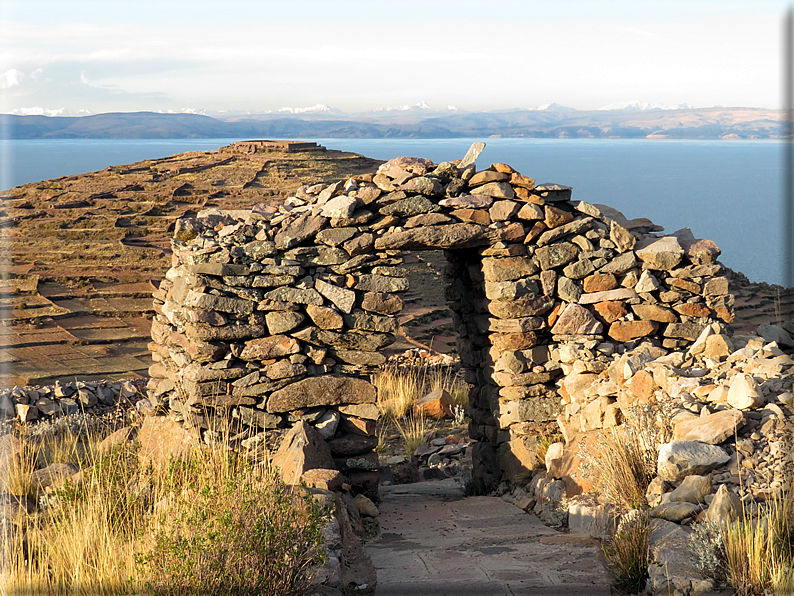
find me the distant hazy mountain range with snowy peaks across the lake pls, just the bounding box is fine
[0,102,785,139]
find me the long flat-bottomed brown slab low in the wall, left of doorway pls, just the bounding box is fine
[266,376,377,413]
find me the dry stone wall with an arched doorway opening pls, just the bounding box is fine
[149,145,732,497]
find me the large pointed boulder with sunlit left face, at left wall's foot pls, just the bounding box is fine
[273,421,336,485]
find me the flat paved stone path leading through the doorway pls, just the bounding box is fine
[366,479,611,596]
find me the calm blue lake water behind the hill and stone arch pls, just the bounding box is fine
[0,139,784,283]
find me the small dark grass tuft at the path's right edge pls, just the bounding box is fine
[604,510,651,593]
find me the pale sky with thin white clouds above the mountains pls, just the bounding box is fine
[0,0,790,114]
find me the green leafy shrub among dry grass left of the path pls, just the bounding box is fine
[140,452,327,596]
